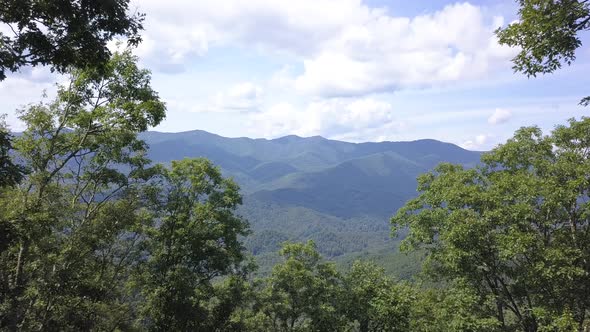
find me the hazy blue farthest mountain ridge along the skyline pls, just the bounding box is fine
[141,130,480,187]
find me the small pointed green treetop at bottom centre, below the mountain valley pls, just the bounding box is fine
[256,241,344,331]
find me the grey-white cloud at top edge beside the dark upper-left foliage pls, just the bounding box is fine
[135,0,371,60]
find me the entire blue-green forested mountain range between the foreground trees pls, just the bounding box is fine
[142,130,481,277]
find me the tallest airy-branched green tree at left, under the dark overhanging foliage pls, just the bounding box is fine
[0,51,165,331]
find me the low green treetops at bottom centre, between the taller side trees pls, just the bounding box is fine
[244,241,415,332]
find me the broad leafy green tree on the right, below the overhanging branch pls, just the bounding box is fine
[392,118,590,331]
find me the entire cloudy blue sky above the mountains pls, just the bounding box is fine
[0,0,590,150]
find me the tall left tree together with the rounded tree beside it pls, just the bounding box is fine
[0,51,250,331]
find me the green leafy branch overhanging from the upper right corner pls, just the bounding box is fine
[496,0,590,106]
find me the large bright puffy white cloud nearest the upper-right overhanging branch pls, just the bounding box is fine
[296,3,513,95]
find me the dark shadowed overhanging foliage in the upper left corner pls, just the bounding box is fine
[0,0,143,81]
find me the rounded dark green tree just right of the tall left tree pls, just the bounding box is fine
[140,159,248,331]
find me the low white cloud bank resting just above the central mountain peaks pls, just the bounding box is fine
[250,97,402,141]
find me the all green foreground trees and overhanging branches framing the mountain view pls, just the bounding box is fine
[0,0,590,332]
